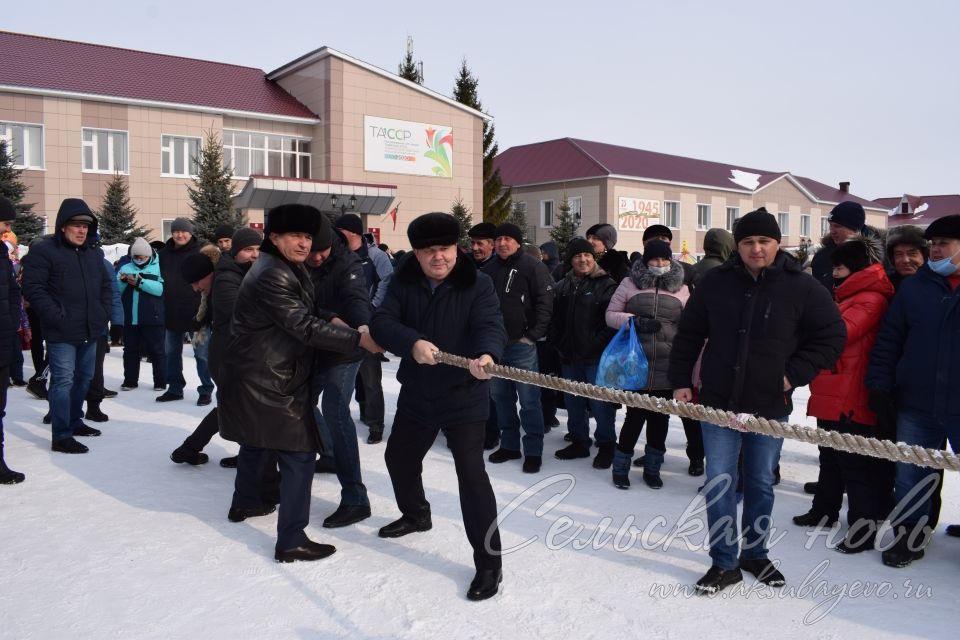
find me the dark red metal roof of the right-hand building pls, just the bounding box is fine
[495,138,877,208]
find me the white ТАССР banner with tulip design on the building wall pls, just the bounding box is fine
[363,116,453,178]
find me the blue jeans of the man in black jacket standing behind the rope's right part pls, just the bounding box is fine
[702,418,786,569]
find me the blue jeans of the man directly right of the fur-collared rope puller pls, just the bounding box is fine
[490,342,543,456]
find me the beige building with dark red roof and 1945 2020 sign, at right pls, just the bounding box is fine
[496,138,887,257]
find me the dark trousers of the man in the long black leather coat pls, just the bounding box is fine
[232,445,302,551]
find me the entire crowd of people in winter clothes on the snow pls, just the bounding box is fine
[0,198,960,600]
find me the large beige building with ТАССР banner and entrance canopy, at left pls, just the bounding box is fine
[0,32,480,248]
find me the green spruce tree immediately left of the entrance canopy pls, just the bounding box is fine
[187,130,240,242]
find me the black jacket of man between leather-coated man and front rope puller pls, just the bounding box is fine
[307,233,373,369]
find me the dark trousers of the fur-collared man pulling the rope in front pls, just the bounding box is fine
[384,414,502,569]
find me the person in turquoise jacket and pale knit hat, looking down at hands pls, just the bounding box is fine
[117,238,166,391]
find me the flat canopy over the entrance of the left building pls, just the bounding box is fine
[233,176,397,216]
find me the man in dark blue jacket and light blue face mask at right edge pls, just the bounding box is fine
[866,215,960,567]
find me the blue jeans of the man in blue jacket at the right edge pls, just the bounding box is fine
[890,409,960,526]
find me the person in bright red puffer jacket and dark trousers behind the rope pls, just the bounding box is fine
[794,237,894,553]
